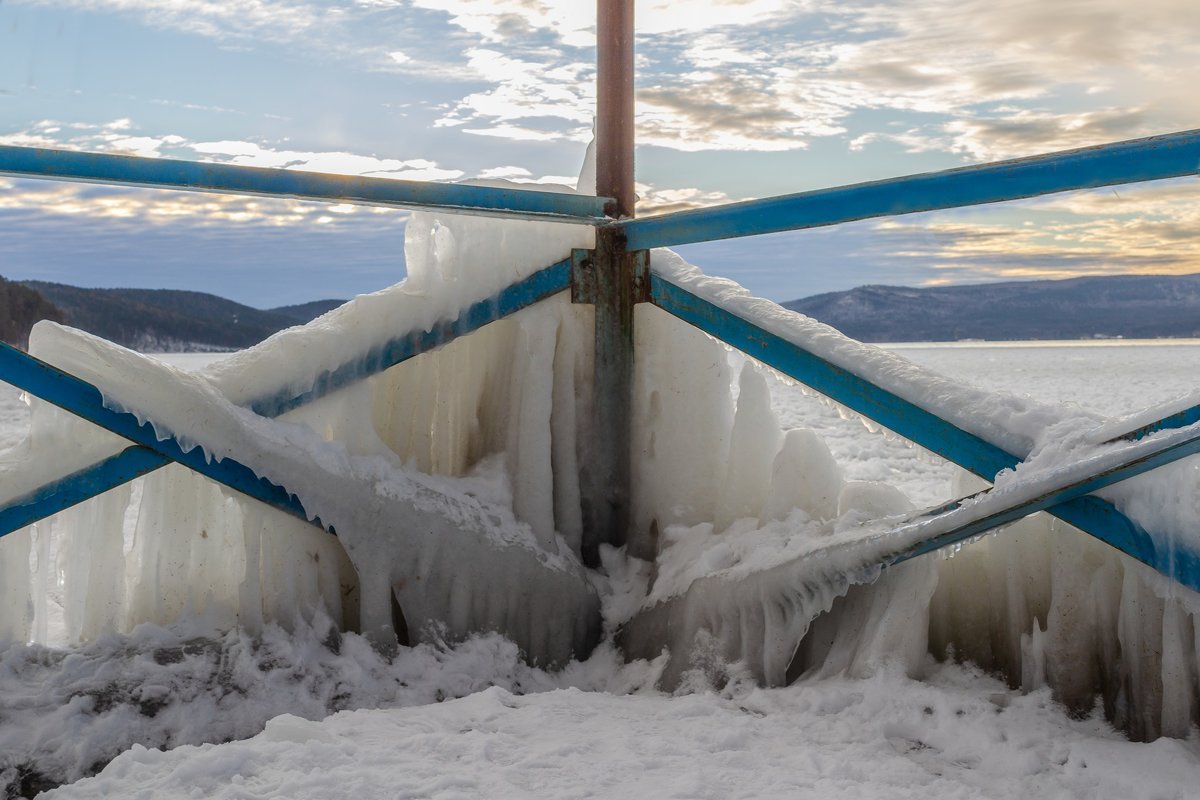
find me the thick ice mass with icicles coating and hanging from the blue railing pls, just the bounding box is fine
[0,167,1200,736]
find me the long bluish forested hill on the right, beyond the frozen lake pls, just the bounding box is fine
[784,275,1200,342]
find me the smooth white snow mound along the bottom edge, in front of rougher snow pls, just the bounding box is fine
[32,667,1196,800]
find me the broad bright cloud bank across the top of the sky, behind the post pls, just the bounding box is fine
[32,0,1200,158]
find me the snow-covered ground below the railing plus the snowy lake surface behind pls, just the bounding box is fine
[0,342,1200,798]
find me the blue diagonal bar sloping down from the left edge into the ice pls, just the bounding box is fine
[0,343,308,532]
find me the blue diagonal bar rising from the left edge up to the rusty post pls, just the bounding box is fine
[0,259,571,536]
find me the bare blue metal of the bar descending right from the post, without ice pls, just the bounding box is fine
[650,269,1200,589]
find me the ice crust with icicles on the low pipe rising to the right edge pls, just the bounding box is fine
[622,400,1195,700]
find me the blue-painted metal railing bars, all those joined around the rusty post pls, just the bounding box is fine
[0,131,1200,597]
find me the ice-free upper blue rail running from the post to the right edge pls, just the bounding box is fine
[618,131,1200,249]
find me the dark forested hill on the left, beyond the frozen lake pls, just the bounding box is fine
[17,281,344,353]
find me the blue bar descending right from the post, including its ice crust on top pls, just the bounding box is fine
[649,257,1200,590]
